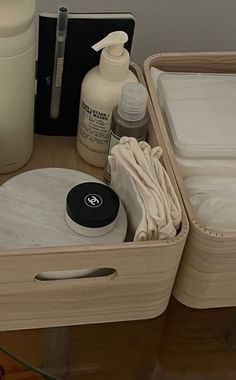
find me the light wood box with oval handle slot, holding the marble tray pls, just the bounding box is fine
[0,65,188,330]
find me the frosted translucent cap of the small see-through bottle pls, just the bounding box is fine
[118,83,148,121]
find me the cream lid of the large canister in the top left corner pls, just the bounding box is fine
[0,0,36,37]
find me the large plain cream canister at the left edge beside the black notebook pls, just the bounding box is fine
[0,0,36,173]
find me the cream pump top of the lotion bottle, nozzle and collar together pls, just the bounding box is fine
[92,31,129,81]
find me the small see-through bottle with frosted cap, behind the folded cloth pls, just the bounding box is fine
[104,83,150,183]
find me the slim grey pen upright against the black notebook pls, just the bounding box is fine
[50,6,68,119]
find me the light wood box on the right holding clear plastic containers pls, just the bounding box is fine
[144,53,236,308]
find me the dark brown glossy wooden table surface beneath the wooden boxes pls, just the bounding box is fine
[0,298,236,380]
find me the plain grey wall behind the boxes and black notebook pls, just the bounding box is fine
[37,0,236,64]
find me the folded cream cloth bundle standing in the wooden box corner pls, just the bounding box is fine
[109,137,181,241]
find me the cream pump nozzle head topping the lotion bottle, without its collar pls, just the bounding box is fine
[92,31,128,57]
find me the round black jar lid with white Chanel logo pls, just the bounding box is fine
[66,182,120,228]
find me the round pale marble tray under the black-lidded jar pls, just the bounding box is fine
[0,168,127,249]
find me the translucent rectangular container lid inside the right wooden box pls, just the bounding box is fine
[157,73,236,158]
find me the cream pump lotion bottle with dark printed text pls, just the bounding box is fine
[77,31,137,167]
